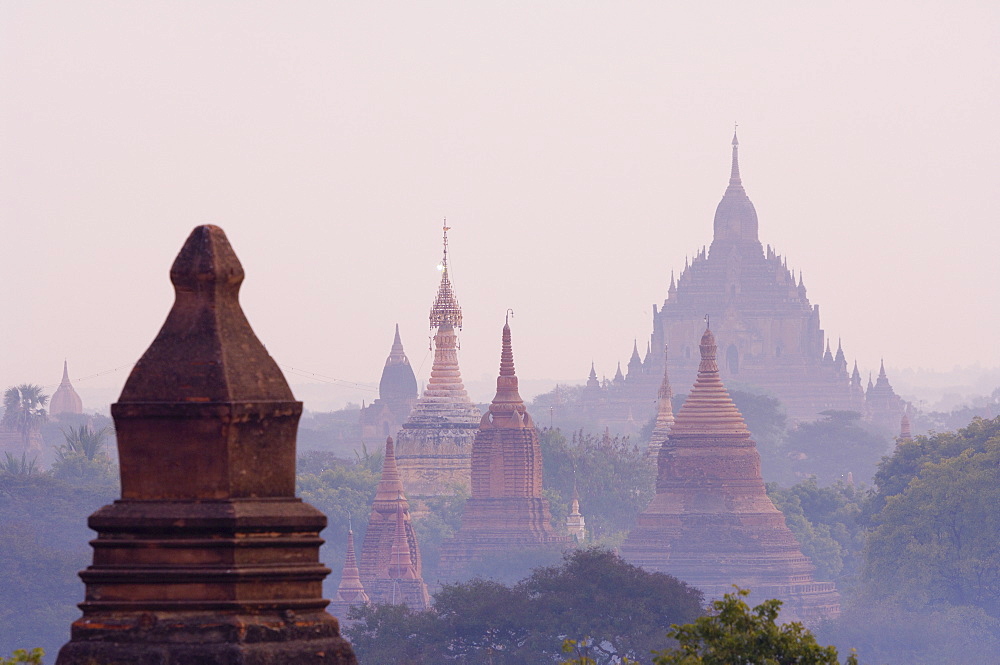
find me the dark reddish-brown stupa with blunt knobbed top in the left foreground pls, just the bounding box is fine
[57,226,356,665]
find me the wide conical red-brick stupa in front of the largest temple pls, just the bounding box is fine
[622,330,840,624]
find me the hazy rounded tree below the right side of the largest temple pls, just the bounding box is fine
[787,411,892,484]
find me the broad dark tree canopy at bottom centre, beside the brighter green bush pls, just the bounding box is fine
[345,548,701,665]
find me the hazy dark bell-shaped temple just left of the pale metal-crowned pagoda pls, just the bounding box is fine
[359,323,417,441]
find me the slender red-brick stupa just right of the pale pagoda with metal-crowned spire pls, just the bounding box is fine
[440,324,571,580]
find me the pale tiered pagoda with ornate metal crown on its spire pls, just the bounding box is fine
[397,226,482,498]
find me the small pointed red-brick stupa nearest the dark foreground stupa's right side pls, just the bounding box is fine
[358,437,430,610]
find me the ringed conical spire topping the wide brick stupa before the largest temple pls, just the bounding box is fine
[670,328,750,440]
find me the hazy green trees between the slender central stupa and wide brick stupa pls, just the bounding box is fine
[539,429,656,539]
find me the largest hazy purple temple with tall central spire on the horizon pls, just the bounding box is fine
[634,133,864,420]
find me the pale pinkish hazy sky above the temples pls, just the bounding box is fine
[0,0,1000,408]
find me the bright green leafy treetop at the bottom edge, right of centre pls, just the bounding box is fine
[653,589,857,665]
